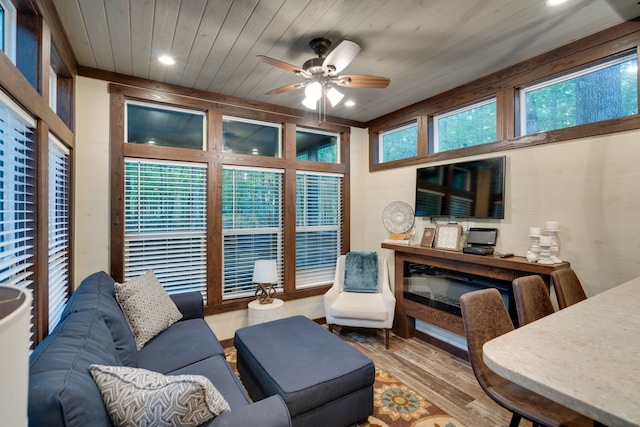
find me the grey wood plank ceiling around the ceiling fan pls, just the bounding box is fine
[53,0,640,122]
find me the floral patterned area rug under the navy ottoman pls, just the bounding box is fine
[225,348,464,427]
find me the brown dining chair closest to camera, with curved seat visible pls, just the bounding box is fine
[460,288,594,427]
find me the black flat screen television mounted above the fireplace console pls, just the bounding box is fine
[415,156,505,219]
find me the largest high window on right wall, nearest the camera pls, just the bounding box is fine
[520,52,638,135]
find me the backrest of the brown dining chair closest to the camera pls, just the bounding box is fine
[460,288,515,390]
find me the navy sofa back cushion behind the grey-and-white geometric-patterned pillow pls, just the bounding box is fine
[29,310,120,427]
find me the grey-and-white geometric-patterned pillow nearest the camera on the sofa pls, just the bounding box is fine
[89,365,230,427]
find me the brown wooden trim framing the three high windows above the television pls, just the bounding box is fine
[366,20,640,172]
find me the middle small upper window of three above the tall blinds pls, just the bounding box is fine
[222,117,282,157]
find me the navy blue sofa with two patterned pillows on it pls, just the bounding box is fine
[29,272,291,427]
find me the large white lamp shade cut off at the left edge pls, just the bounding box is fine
[0,286,31,427]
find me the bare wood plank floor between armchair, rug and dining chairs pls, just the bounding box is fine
[333,326,531,427]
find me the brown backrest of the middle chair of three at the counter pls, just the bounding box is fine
[512,275,555,326]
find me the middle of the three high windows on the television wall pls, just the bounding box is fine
[433,98,497,153]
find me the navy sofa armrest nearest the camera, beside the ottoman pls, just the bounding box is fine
[205,394,291,427]
